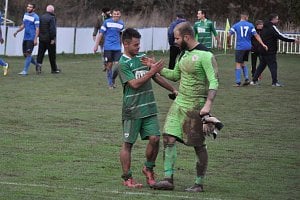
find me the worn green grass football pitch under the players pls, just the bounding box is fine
[0,52,300,200]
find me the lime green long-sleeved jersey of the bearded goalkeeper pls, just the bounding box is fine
[160,45,219,109]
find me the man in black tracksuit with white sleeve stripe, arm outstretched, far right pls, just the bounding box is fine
[250,14,299,87]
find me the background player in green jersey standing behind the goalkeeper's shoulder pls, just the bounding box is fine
[194,10,222,49]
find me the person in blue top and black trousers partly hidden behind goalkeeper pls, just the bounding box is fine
[168,13,186,69]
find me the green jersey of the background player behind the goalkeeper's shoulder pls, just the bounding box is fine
[194,19,218,48]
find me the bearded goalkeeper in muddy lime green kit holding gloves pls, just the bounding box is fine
[143,22,218,192]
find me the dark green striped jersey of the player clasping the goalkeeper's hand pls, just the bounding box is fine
[119,53,157,120]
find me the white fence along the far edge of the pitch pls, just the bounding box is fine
[0,27,300,56]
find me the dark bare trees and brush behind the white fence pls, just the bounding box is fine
[2,0,300,32]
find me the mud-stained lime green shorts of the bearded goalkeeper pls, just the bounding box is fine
[163,103,205,146]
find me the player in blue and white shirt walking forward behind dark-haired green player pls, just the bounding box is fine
[94,9,125,89]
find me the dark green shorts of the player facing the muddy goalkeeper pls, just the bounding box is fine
[123,115,160,144]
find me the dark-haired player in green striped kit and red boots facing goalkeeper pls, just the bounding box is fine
[119,28,177,188]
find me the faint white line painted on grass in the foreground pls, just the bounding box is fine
[0,182,221,200]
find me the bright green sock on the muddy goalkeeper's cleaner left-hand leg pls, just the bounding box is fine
[164,144,177,178]
